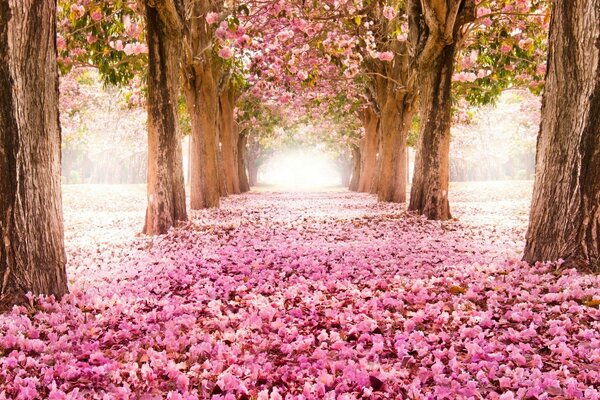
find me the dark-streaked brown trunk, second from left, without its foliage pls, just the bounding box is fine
[143,2,187,235]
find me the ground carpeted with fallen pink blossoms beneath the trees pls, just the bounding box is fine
[0,182,600,400]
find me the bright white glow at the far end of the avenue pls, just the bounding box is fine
[259,150,341,190]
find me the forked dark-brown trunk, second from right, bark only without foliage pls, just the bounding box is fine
[408,0,475,220]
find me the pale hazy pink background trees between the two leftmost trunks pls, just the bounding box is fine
[59,67,148,184]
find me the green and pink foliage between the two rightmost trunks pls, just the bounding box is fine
[454,0,550,105]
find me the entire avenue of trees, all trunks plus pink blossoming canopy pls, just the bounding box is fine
[0,0,600,304]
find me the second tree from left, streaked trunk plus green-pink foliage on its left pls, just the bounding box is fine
[57,0,187,234]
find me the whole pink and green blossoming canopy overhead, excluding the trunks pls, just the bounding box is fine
[58,0,549,155]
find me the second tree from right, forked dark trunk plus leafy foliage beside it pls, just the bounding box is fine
[408,0,547,220]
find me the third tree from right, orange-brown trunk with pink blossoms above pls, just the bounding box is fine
[336,1,417,203]
